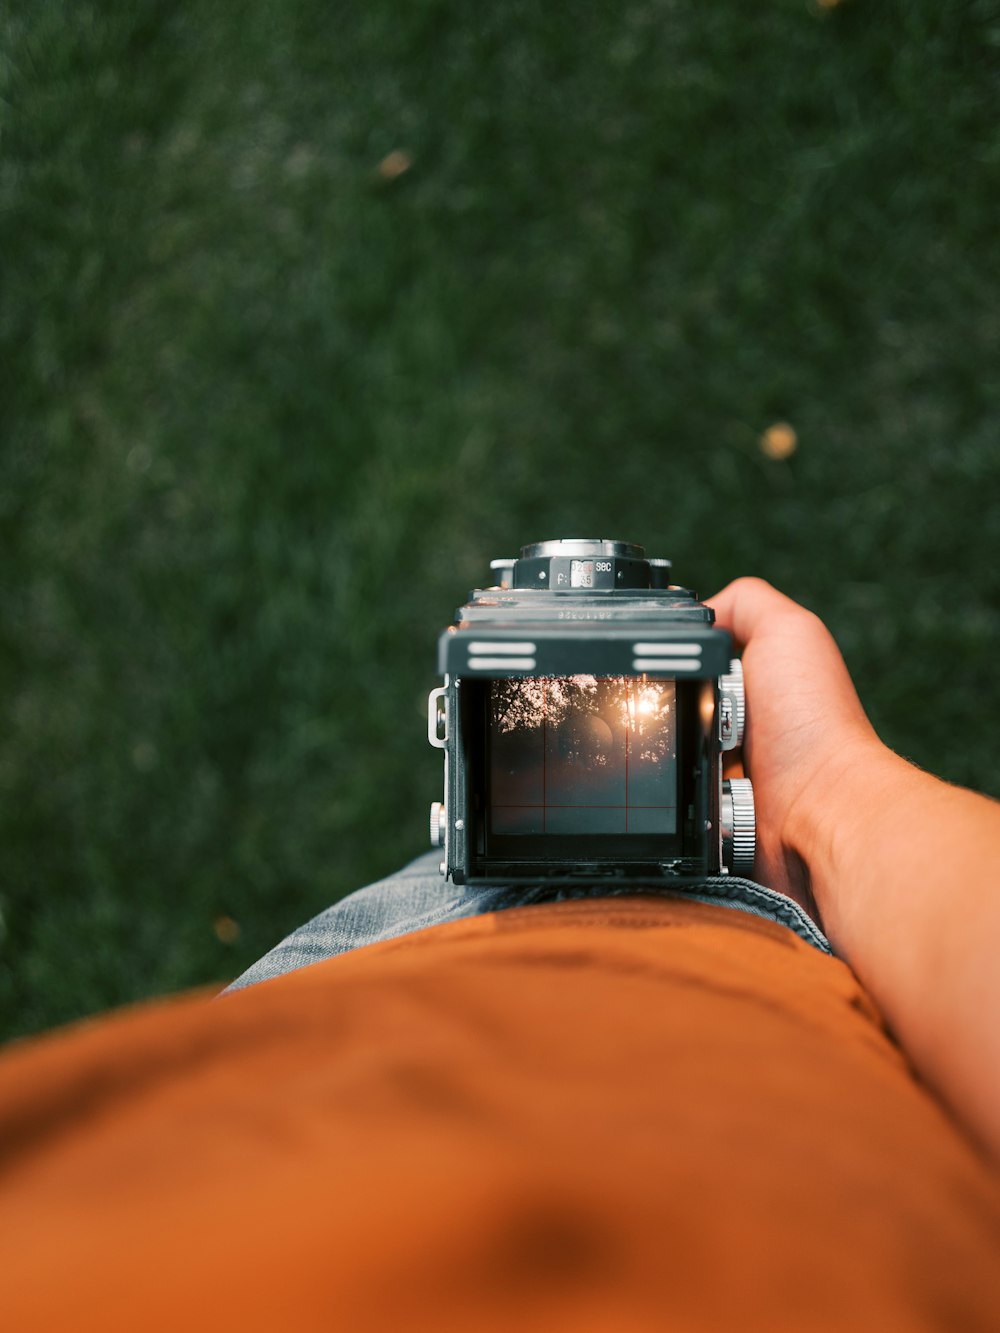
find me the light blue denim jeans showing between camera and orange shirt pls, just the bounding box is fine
[228,852,833,990]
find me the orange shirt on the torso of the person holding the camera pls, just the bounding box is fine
[0,896,1000,1333]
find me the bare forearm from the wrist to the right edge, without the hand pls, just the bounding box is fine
[789,740,1000,1160]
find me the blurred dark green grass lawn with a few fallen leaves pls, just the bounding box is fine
[0,0,1000,1036]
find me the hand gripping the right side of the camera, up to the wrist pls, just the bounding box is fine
[708,579,883,916]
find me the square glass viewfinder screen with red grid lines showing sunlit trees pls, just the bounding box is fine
[489,676,677,834]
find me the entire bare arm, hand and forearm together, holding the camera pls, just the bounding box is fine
[712,579,1000,1160]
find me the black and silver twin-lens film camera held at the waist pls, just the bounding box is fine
[428,540,756,885]
